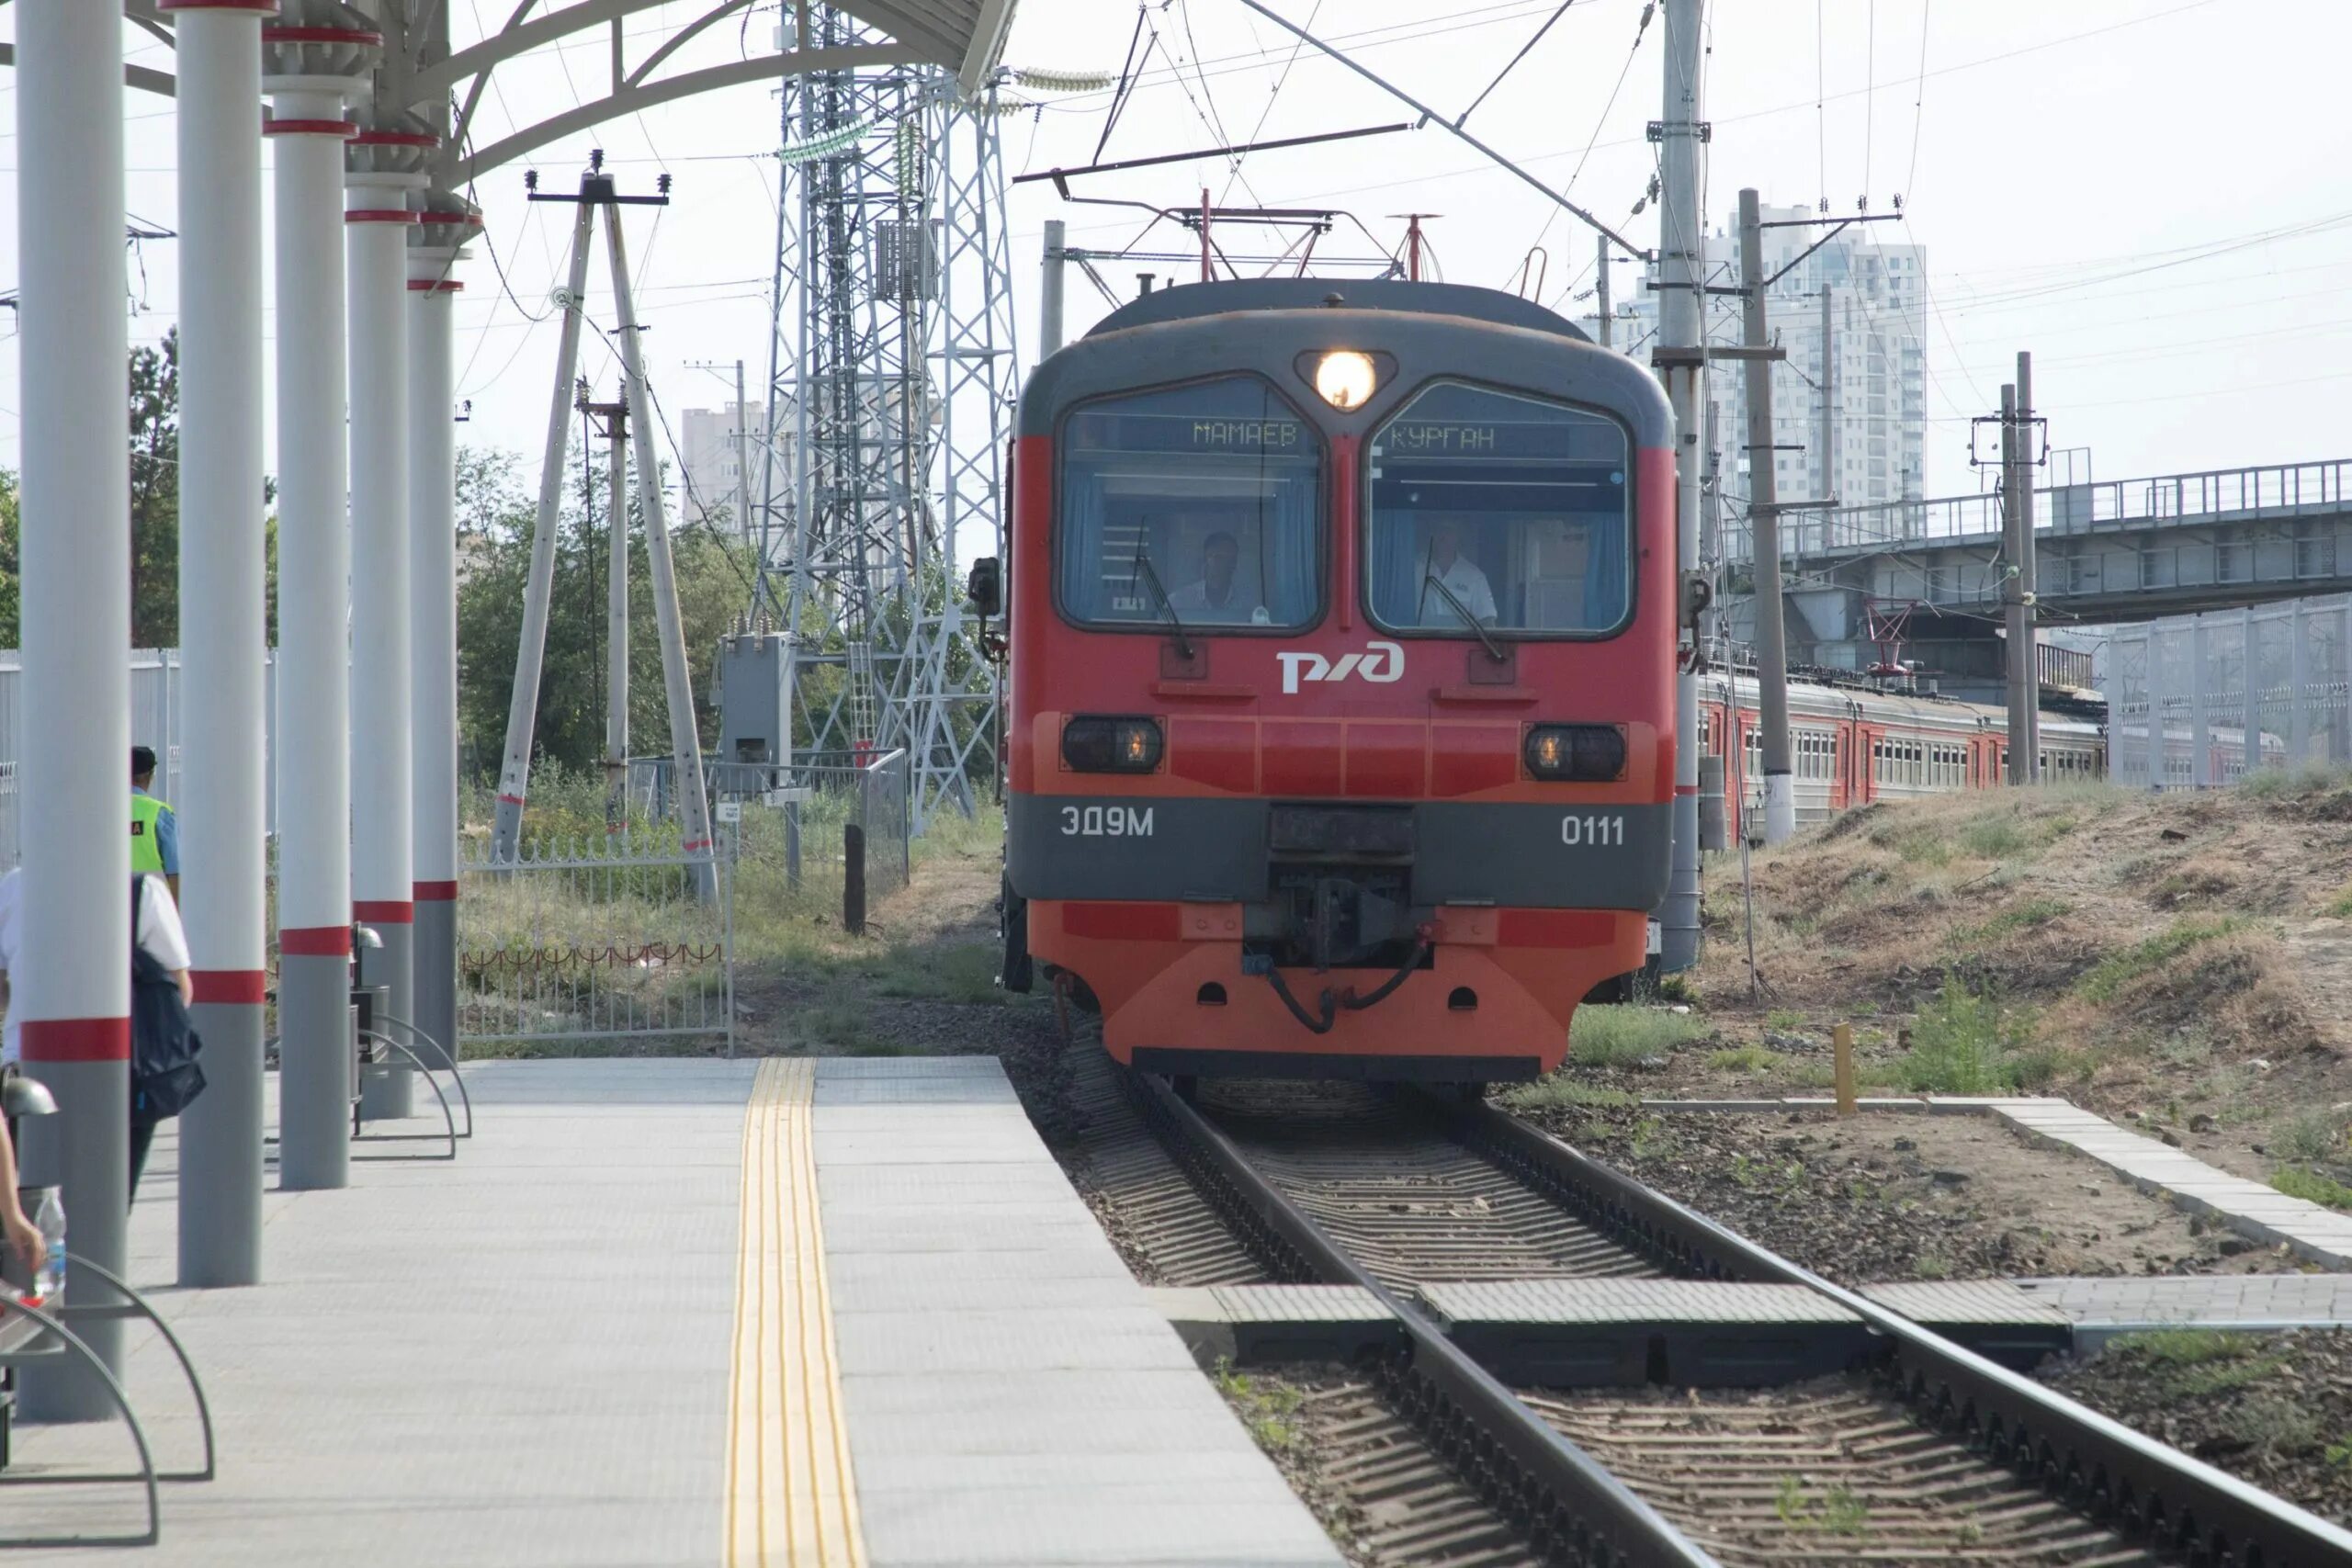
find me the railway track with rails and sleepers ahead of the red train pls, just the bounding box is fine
[1117,1075,2352,1568]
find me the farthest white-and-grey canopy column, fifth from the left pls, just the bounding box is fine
[409,186,482,1081]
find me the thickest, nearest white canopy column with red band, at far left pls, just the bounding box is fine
[9,0,131,1420]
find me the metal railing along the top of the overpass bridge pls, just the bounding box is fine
[1724,458,2352,562]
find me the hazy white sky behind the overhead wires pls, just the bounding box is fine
[0,0,2352,512]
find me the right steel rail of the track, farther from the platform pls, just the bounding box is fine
[1449,1105,2352,1568]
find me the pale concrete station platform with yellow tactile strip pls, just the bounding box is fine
[0,1058,1340,1568]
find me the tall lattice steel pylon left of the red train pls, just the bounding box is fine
[757,7,1013,832]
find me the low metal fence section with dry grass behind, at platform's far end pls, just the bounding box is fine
[457,828,734,1055]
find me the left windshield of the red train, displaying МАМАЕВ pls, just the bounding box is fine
[1054,376,1327,630]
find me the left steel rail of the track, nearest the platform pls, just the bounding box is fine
[1126,1072,1719,1568]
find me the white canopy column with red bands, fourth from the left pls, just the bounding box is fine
[344,104,440,1122]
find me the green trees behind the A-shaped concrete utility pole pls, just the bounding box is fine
[457,449,751,776]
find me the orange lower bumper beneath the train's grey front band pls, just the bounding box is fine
[1028,900,1646,1072]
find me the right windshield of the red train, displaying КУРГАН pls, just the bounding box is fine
[1364,383,1633,637]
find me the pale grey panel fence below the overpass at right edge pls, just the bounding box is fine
[2108,594,2352,790]
